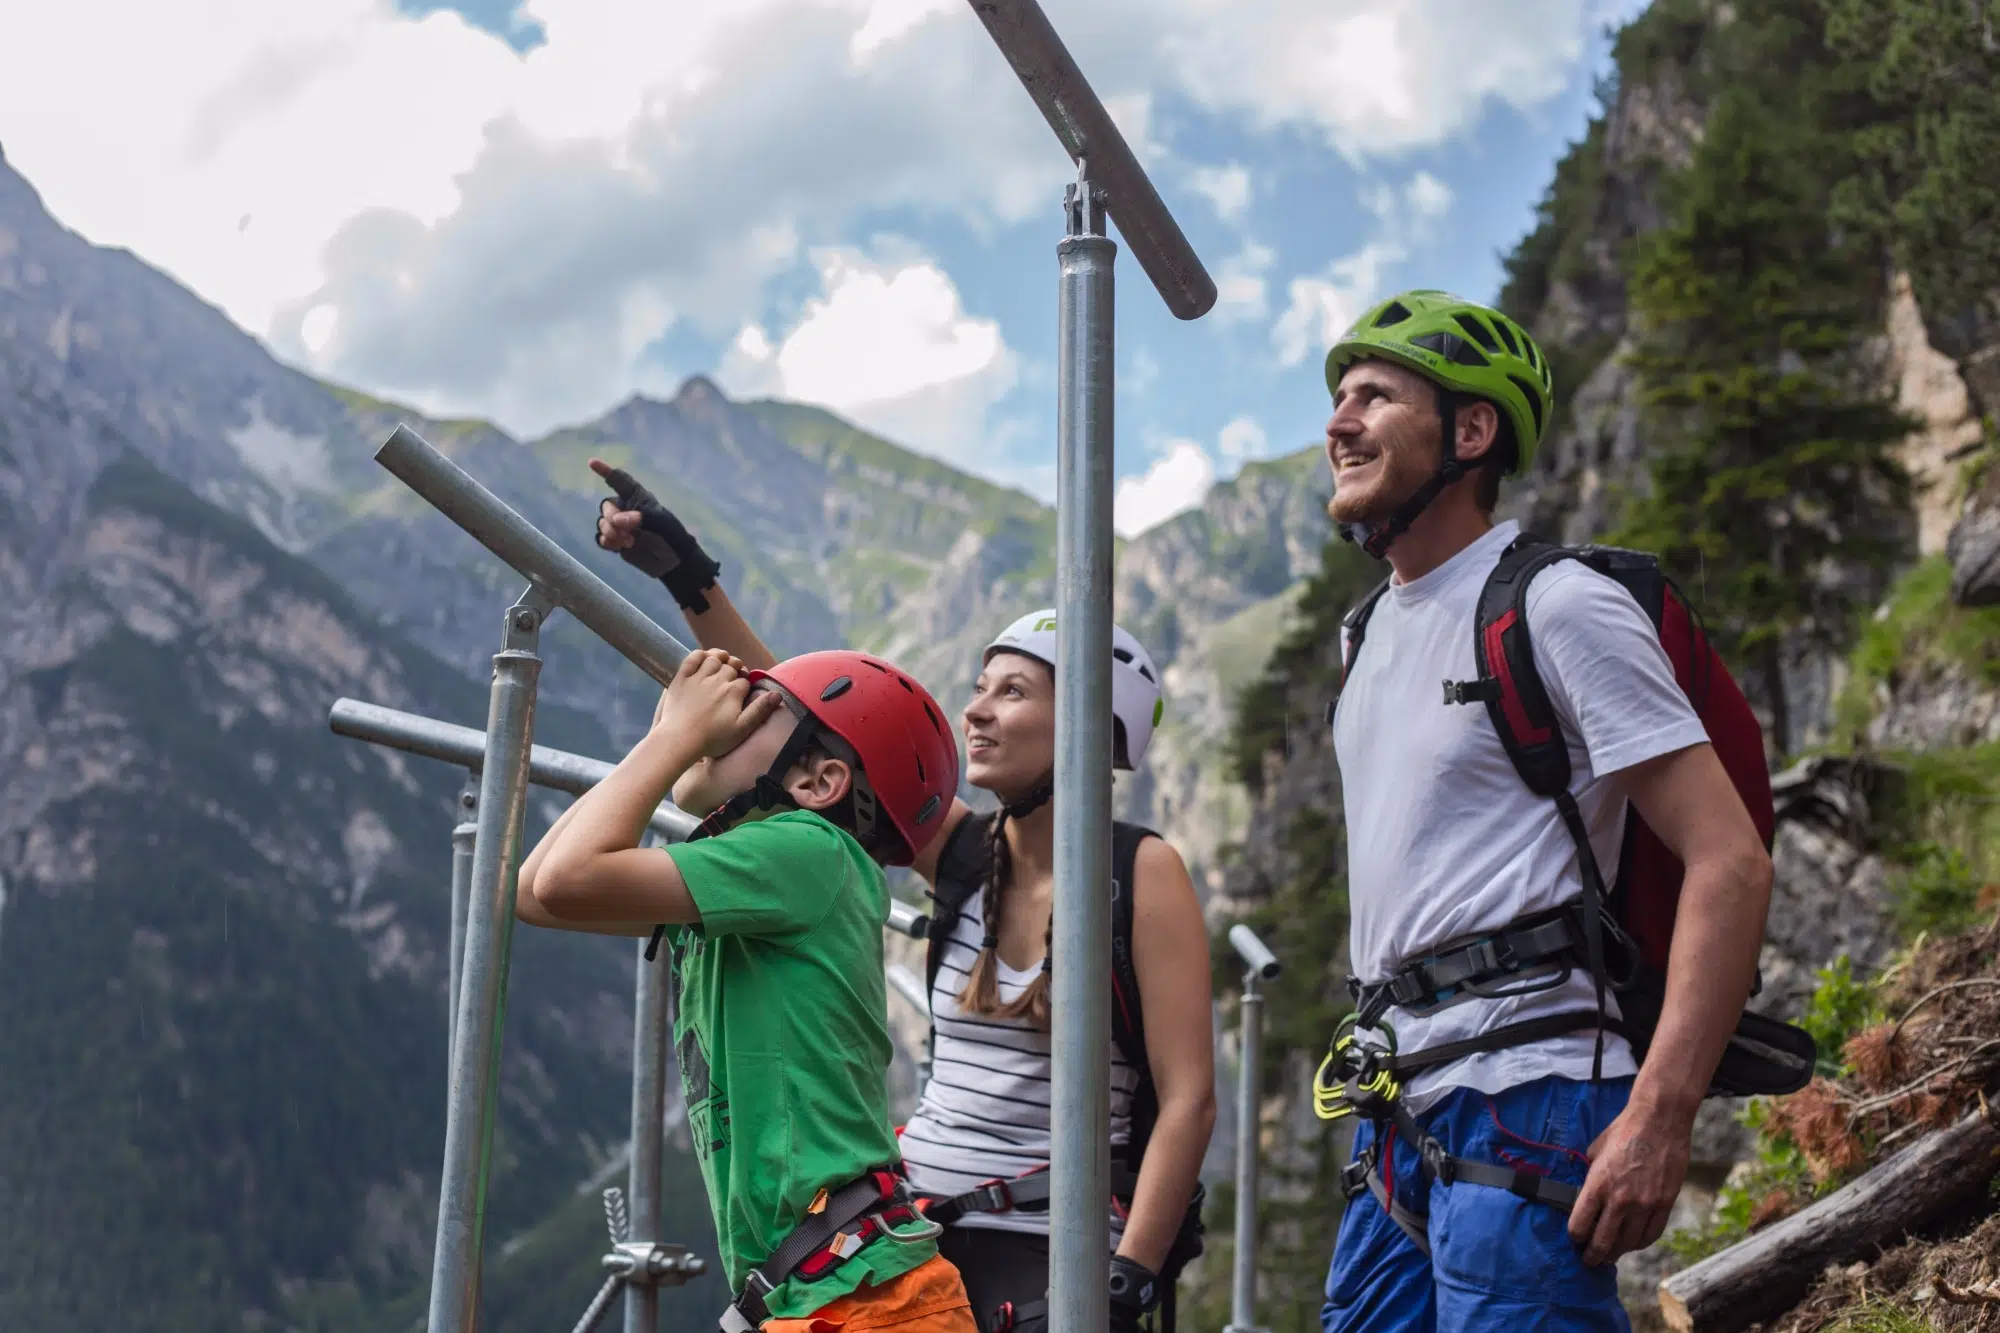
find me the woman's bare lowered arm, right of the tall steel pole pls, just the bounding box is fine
[1118,839,1216,1273]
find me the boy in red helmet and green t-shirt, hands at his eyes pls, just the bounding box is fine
[516,650,974,1333]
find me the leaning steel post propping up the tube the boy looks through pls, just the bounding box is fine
[430,588,554,1333]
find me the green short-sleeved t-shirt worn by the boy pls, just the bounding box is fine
[668,811,938,1317]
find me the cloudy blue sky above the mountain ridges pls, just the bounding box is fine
[0,0,1642,532]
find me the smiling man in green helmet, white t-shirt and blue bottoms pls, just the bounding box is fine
[1322,290,1770,1333]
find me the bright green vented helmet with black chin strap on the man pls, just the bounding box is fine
[1326,288,1556,558]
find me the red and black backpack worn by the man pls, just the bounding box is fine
[1340,536,1816,1097]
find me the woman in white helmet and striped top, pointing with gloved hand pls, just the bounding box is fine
[592,460,1216,1333]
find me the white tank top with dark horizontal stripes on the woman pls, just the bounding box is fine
[902,889,1138,1247]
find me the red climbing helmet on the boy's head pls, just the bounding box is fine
[750,648,958,865]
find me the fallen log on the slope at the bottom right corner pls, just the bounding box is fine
[1660,1105,2000,1333]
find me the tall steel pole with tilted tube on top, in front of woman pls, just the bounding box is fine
[970,0,1216,1333]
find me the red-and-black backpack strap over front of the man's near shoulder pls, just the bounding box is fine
[1444,536,1578,797]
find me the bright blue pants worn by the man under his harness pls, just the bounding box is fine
[1320,1077,1632,1333]
